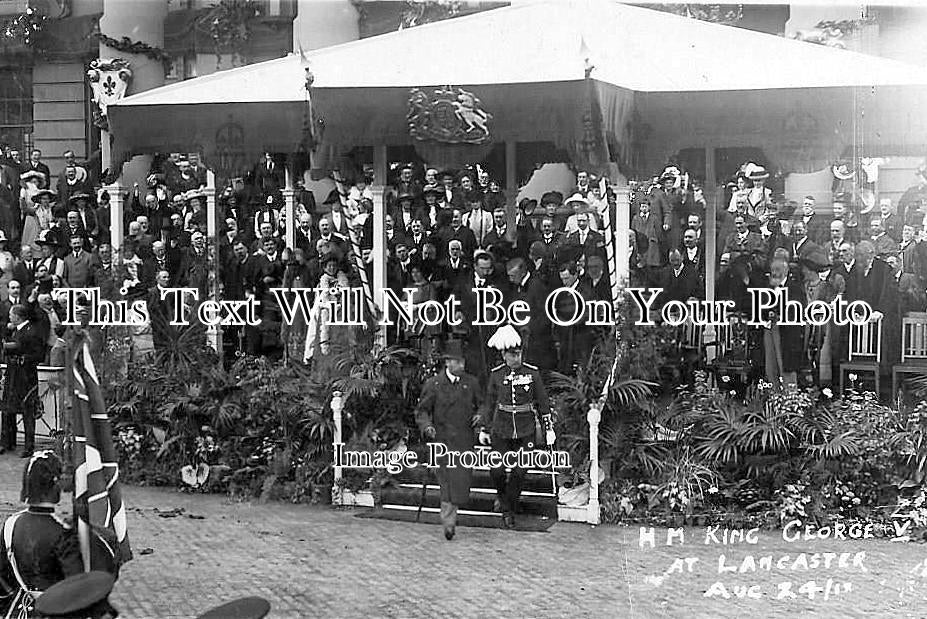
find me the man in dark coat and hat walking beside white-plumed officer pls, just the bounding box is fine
[415,341,480,541]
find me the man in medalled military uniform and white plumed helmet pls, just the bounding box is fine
[479,325,557,529]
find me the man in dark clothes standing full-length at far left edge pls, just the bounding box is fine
[0,305,45,458]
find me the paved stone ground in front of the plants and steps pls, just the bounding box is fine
[0,456,927,619]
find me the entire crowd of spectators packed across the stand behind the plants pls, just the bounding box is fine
[0,148,927,394]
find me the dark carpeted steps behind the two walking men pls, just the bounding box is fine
[381,446,559,525]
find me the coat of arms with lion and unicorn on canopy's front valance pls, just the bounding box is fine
[408,86,492,144]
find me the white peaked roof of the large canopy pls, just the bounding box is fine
[115,0,927,107]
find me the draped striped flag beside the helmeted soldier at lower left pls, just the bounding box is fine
[71,336,132,571]
